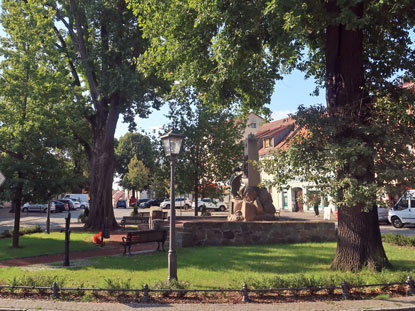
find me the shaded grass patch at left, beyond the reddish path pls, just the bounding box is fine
[0,232,96,260]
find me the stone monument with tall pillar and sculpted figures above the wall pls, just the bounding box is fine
[228,134,276,221]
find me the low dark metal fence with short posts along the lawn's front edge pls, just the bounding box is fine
[0,276,415,303]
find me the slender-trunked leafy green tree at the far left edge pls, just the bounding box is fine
[0,1,76,247]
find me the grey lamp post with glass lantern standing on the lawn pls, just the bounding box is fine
[160,130,184,281]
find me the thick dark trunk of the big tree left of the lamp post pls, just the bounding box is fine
[85,106,119,230]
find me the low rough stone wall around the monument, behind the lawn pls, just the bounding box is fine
[177,221,336,247]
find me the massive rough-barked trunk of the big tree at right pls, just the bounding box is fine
[326,0,390,271]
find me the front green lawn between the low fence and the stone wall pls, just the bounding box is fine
[0,243,415,288]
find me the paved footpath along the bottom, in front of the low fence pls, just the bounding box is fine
[0,297,415,311]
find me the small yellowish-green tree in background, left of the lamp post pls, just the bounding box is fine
[122,155,150,192]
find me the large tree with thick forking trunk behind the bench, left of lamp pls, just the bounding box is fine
[2,0,169,229]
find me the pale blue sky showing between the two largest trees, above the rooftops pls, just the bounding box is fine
[115,70,325,138]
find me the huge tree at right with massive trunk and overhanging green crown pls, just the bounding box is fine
[130,0,415,270]
